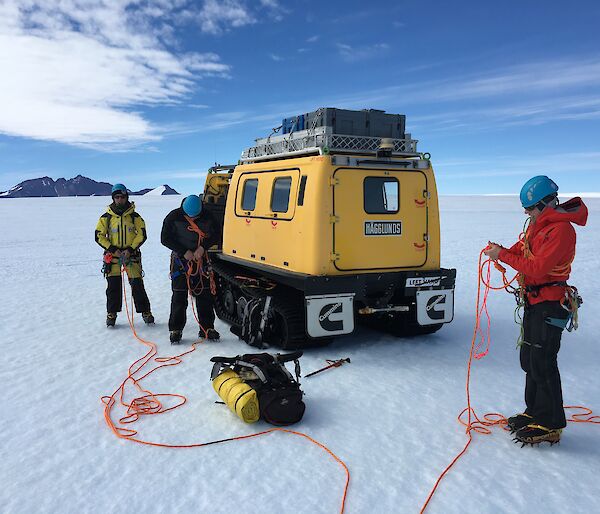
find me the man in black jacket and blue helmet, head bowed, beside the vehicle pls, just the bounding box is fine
[160,195,221,344]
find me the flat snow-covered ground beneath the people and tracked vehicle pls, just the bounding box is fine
[0,196,600,514]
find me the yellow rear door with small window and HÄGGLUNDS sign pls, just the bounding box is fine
[332,167,427,271]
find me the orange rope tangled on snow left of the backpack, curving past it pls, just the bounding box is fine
[101,267,350,513]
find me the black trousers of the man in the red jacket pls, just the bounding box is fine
[520,302,568,428]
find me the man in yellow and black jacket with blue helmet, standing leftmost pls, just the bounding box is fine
[95,184,154,327]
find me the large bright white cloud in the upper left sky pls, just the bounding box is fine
[0,0,229,150]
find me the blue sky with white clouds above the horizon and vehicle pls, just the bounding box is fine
[0,0,600,194]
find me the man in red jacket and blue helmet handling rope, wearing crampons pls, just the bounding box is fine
[484,176,588,443]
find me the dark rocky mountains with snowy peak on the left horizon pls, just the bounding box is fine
[0,175,179,198]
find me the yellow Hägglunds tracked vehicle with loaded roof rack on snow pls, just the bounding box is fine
[203,108,456,349]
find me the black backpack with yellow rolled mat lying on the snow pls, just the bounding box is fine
[211,352,305,426]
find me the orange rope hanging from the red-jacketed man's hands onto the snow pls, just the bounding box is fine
[420,248,600,508]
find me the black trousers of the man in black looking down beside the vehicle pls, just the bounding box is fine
[169,256,215,330]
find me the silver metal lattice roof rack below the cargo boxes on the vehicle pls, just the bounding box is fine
[240,126,420,162]
